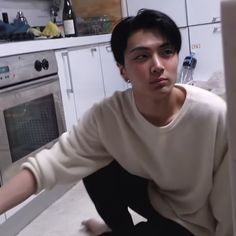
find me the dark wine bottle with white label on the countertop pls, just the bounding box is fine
[63,0,76,37]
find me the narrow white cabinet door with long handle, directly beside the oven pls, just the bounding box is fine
[55,50,77,130]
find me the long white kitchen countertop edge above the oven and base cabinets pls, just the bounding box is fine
[0,34,111,57]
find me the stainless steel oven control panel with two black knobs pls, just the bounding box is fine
[0,50,58,88]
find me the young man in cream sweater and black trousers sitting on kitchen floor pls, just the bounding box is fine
[0,10,233,236]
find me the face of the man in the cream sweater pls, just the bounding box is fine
[120,30,178,99]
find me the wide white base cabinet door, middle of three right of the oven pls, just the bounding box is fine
[68,47,105,119]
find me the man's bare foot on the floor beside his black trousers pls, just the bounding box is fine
[81,219,111,235]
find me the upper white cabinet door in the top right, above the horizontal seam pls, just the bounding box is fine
[186,0,221,25]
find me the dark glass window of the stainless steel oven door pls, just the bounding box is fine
[4,94,59,162]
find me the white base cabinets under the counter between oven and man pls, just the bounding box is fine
[56,43,127,127]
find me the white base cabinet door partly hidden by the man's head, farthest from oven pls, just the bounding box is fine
[99,44,127,97]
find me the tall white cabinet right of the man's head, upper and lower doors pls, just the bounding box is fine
[186,0,224,81]
